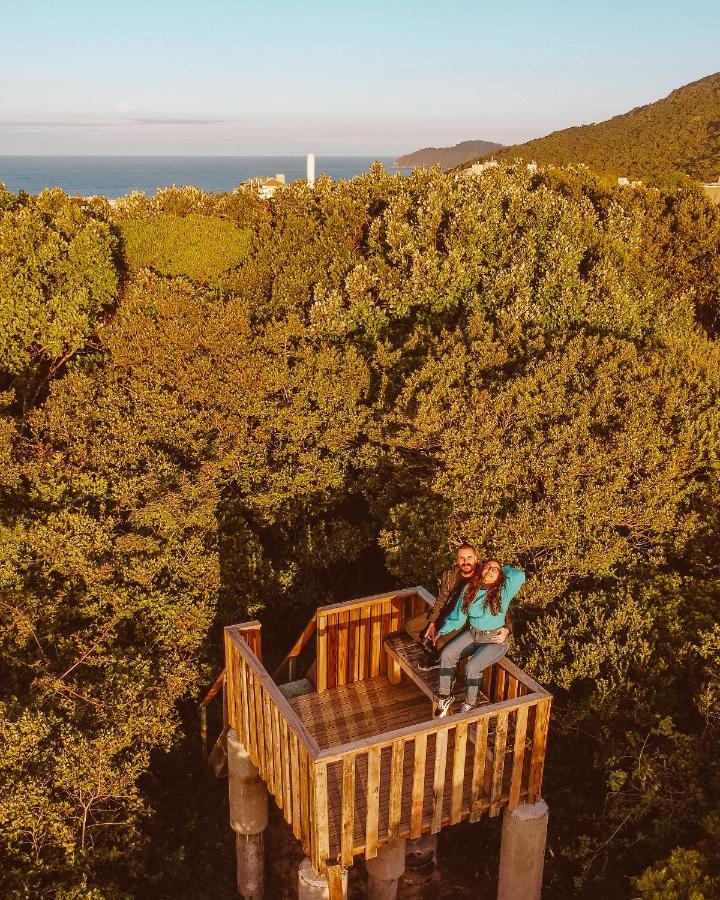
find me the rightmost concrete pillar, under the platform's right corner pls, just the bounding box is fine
[498,800,548,900]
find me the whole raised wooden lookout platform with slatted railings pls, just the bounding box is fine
[225,588,552,884]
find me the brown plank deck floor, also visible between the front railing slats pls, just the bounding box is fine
[290,672,512,857]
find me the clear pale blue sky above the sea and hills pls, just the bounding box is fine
[0,0,720,156]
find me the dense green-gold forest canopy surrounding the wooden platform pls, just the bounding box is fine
[0,166,720,898]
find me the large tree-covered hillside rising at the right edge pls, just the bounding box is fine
[462,73,720,182]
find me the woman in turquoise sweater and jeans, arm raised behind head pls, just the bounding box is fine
[433,559,525,719]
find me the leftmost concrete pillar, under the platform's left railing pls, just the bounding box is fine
[228,729,268,900]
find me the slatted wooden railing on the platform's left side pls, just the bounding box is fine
[225,625,320,854]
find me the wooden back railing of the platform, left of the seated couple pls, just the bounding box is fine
[316,587,435,693]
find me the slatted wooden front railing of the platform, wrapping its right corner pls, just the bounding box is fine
[315,660,551,865]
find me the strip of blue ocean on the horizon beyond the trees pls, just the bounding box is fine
[0,156,394,198]
